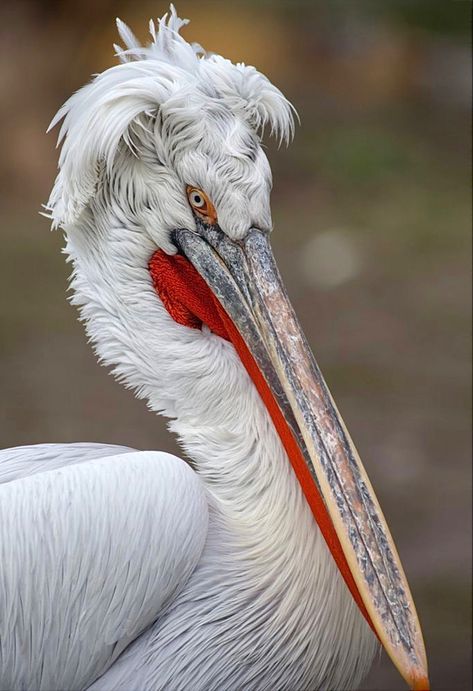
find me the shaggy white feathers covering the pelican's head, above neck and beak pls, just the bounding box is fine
[47,5,294,243]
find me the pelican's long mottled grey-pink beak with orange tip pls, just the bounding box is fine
[174,224,429,691]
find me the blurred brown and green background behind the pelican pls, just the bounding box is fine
[0,0,471,691]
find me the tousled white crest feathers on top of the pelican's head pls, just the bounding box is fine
[46,5,294,227]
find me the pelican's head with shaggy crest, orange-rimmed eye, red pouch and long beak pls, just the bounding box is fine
[48,6,428,689]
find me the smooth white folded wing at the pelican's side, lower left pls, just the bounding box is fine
[0,451,208,691]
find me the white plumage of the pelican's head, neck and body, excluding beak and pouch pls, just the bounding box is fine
[0,8,428,691]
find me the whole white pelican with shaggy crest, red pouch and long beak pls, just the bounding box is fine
[0,6,429,691]
